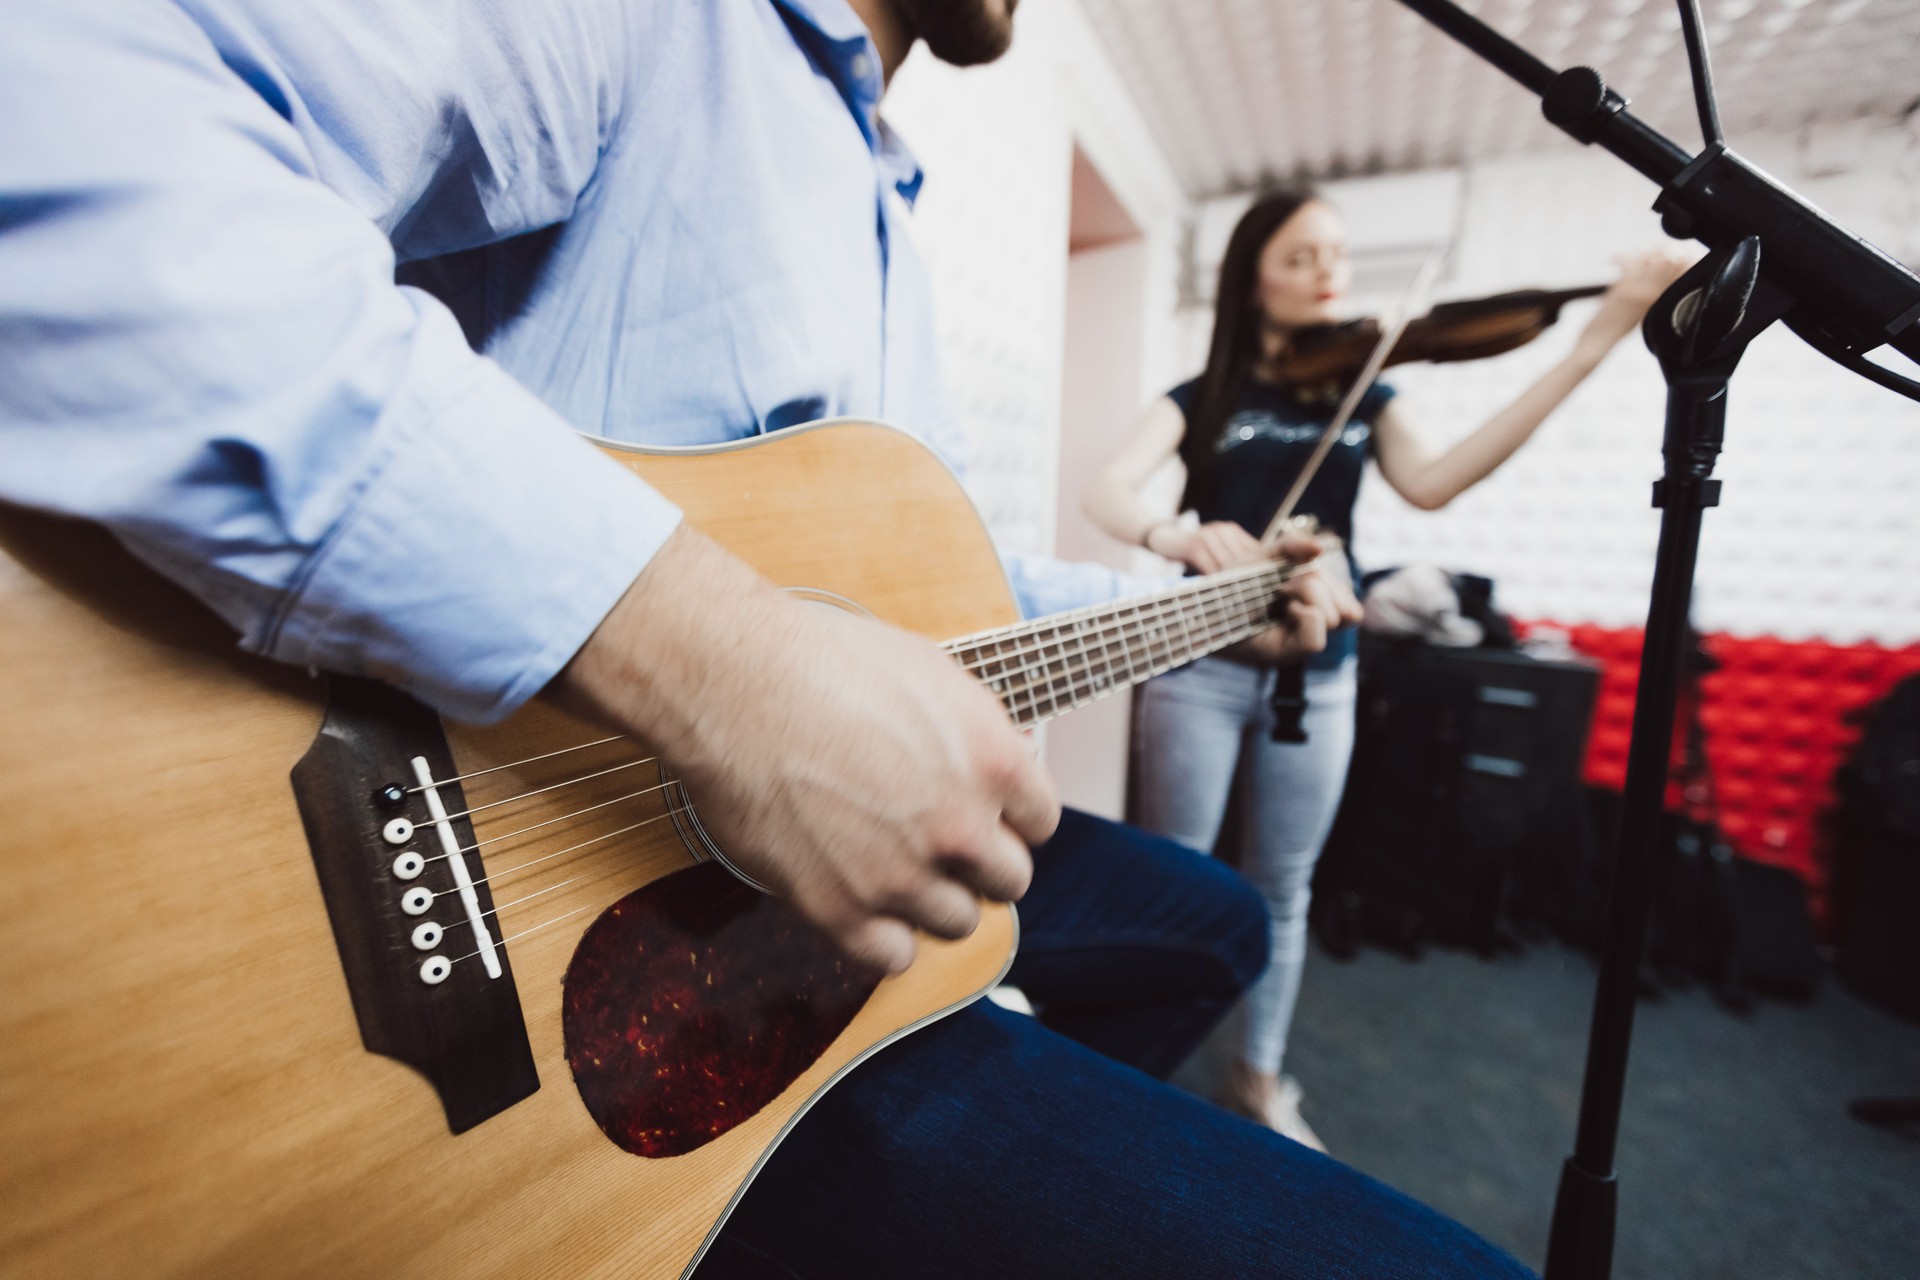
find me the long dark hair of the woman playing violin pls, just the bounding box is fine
[1181,186,1319,509]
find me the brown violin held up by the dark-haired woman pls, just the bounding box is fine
[1275,284,1609,399]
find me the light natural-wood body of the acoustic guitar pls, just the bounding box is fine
[0,422,1018,1278]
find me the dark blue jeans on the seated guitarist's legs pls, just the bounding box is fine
[697,812,1530,1280]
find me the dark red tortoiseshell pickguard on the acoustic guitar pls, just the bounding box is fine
[563,864,879,1159]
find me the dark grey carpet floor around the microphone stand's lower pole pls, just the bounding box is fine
[1179,946,1920,1280]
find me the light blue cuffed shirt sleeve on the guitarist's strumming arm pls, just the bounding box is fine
[0,0,680,720]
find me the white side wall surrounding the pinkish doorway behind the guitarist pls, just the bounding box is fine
[885,0,1187,564]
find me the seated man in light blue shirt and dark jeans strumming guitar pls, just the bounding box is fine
[0,0,1511,1276]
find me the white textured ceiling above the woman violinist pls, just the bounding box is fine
[1081,0,1920,196]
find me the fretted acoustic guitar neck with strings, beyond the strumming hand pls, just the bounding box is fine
[945,560,1298,727]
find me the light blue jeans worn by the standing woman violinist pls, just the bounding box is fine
[1129,658,1356,1075]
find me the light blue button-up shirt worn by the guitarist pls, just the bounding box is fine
[0,0,1133,720]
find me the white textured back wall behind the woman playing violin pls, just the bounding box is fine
[1185,125,1920,645]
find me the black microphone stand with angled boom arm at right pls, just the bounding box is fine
[1400,0,1920,1280]
